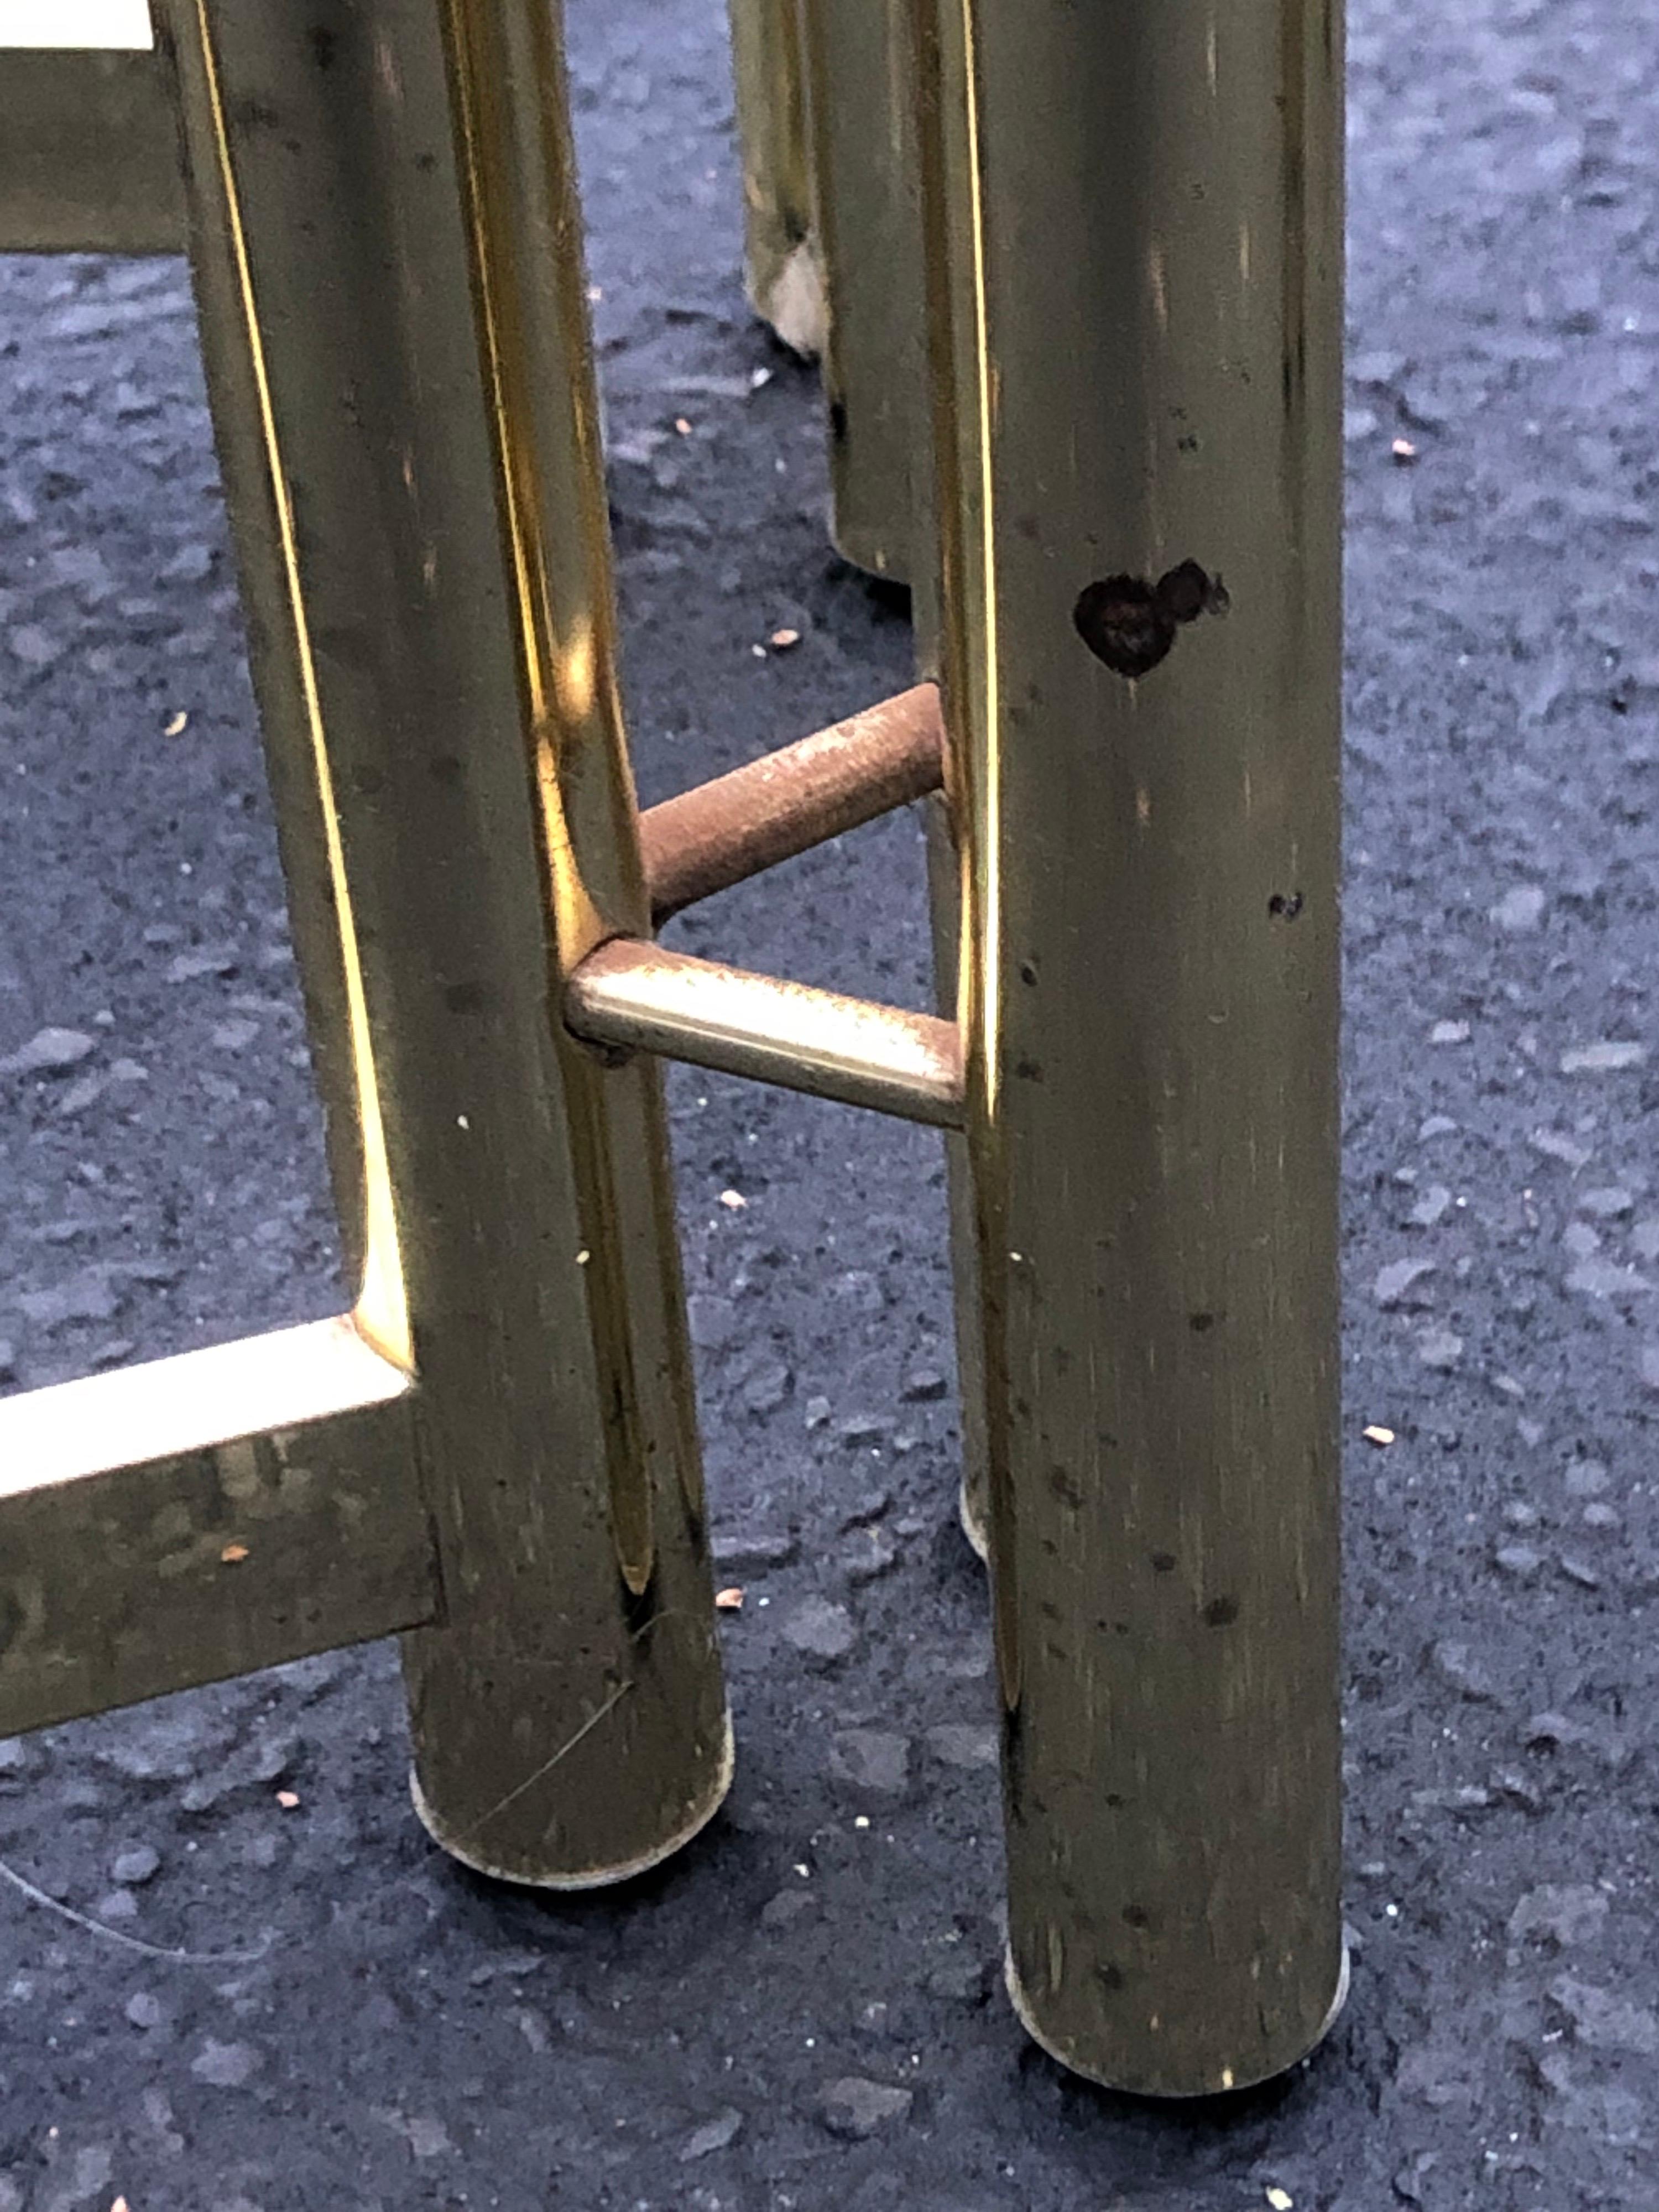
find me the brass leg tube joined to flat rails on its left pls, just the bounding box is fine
[157,0,732,1887]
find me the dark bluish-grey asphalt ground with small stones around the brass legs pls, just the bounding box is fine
[0,0,1659,2212]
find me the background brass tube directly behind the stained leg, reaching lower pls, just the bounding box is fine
[801,0,927,582]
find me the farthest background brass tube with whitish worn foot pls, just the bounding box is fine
[728,0,825,358]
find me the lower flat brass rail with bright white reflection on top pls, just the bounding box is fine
[0,1316,440,1736]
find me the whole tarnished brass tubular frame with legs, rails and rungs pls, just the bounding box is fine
[0,0,1347,2095]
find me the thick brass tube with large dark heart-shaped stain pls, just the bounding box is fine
[911,0,1345,2097]
